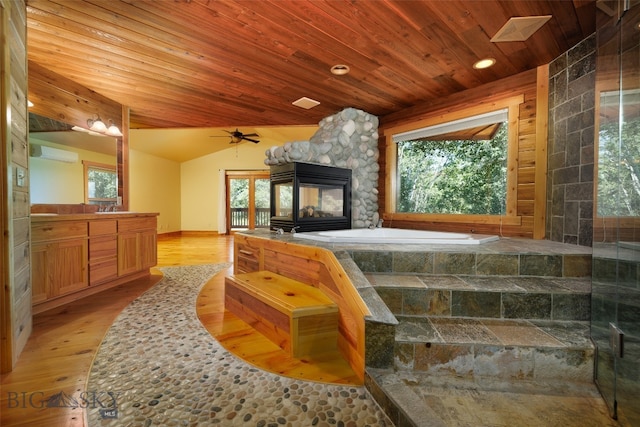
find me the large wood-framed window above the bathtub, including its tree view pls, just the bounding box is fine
[385,95,524,225]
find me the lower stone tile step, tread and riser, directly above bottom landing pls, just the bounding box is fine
[394,317,594,382]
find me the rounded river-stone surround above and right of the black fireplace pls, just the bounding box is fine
[264,108,380,228]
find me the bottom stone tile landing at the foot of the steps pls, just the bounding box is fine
[365,368,626,427]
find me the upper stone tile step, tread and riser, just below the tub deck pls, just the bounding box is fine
[367,274,591,321]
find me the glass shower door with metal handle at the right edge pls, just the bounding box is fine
[591,1,640,425]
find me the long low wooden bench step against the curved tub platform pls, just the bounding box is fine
[224,271,338,358]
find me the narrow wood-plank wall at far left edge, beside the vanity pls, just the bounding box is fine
[0,0,32,373]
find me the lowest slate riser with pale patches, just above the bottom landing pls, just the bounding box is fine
[394,343,593,383]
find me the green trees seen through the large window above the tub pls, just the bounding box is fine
[397,122,508,215]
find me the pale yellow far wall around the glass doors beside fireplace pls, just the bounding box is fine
[180,144,269,232]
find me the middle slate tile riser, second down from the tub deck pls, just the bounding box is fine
[376,287,591,321]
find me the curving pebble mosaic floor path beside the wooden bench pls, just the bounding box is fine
[87,264,393,427]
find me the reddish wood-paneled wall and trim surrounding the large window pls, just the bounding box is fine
[378,66,549,239]
